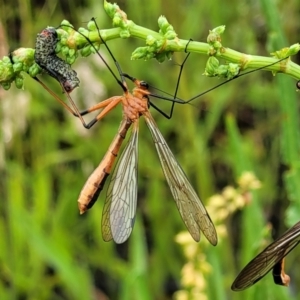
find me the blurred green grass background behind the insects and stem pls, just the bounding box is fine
[0,0,300,300]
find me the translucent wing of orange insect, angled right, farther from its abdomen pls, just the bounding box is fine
[144,111,218,245]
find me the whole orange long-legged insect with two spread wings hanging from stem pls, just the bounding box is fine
[33,23,217,245]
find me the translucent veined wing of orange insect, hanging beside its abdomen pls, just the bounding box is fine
[102,120,138,244]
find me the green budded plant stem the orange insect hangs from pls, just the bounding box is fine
[0,1,300,89]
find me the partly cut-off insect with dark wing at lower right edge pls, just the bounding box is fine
[231,222,300,291]
